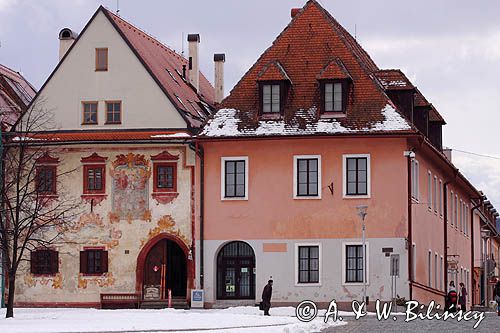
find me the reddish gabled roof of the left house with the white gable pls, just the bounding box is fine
[29,6,215,128]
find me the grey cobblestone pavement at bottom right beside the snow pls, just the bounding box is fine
[322,313,500,333]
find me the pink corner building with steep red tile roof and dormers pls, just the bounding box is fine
[196,0,496,306]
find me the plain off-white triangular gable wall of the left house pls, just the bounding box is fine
[35,12,186,129]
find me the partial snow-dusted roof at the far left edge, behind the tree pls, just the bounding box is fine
[0,64,36,125]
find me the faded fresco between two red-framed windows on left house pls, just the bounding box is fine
[110,153,151,221]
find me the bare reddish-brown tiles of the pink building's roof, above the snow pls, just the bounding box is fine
[210,0,411,135]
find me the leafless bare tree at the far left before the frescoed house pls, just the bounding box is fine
[0,102,79,318]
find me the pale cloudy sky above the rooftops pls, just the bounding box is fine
[0,0,500,208]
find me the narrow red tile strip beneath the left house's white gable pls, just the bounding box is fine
[28,130,191,143]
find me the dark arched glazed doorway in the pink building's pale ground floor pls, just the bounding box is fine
[217,241,255,299]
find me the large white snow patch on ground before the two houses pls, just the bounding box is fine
[0,306,345,333]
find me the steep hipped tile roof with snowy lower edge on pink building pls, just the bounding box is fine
[201,0,416,137]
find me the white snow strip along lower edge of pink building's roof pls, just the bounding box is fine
[200,104,411,137]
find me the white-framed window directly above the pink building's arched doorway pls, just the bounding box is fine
[222,157,248,199]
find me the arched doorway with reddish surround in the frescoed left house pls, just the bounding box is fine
[137,236,190,300]
